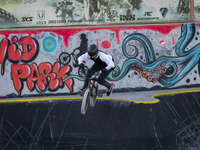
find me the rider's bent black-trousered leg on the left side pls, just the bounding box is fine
[79,64,102,89]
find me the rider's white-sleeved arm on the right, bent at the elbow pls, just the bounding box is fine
[99,52,115,70]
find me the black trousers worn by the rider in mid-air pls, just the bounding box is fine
[83,63,113,88]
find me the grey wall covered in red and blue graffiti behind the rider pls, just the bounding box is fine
[0,24,200,97]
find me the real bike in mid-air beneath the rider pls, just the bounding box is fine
[81,73,101,115]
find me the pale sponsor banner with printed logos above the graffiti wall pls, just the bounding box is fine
[0,0,190,28]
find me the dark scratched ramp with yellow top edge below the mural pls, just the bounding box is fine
[0,90,200,150]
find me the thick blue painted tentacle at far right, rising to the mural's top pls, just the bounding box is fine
[160,24,200,86]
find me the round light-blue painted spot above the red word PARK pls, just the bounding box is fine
[42,36,57,52]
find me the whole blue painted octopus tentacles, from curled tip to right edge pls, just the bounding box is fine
[108,24,200,86]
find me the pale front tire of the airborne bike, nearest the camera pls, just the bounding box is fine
[81,89,90,115]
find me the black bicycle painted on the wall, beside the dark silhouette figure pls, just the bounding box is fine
[59,48,88,77]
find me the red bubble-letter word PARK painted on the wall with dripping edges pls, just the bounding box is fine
[11,62,74,95]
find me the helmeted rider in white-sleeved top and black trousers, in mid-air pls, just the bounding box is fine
[78,44,115,96]
